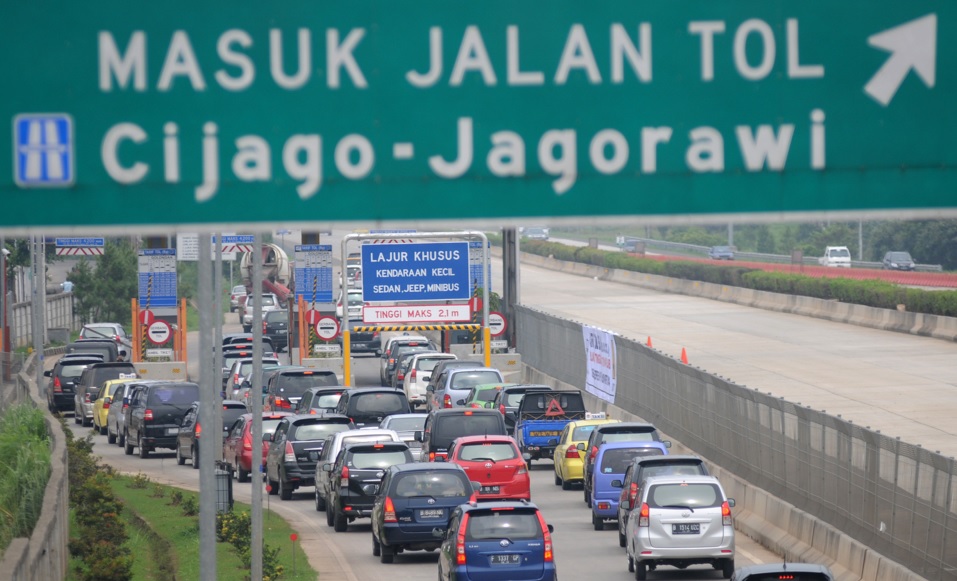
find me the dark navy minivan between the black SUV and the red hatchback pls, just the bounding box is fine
[372,462,478,563]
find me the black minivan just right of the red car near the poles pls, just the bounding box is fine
[266,414,355,500]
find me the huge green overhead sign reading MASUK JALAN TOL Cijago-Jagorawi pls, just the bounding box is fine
[0,0,957,230]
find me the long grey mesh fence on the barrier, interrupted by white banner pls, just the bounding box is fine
[516,307,957,581]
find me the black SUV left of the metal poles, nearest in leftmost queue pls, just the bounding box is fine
[123,381,199,458]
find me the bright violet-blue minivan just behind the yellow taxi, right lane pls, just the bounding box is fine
[591,442,668,531]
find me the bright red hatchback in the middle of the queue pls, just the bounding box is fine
[448,436,532,500]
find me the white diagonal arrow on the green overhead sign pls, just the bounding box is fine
[864,14,937,107]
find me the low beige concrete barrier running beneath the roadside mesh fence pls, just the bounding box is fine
[522,365,924,581]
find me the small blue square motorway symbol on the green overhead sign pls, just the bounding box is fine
[13,113,76,188]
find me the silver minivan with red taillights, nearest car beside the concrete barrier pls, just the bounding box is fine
[625,476,734,581]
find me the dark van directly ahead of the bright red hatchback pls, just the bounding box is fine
[415,408,508,462]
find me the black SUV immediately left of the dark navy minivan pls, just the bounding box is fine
[322,442,414,533]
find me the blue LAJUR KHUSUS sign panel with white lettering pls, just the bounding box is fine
[362,242,472,302]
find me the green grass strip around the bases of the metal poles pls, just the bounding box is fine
[100,476,318,581]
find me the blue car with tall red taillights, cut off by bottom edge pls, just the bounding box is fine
[435,500,558,581]
